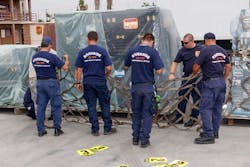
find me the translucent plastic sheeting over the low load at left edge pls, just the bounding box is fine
[0,45,36,107]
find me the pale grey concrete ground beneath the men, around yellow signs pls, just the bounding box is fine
[0,111,250,167]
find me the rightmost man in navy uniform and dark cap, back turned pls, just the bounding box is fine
[193,33,231,144]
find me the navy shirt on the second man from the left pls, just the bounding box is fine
[75,45,112,82]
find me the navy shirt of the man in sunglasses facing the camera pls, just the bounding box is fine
[174,44,205,76]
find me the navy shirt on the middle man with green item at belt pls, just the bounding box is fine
[124,45,164,84]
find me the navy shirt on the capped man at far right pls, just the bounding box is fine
[195,45,230,80]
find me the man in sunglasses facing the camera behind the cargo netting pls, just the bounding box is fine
[169,33,204,127]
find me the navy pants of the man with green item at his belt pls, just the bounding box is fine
[131,86,154,143]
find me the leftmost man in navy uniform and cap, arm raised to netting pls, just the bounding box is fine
[32,36,69,137]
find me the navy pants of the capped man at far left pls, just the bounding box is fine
[37,79,62,133]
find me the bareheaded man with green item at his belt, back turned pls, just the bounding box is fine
[124,33,164,147]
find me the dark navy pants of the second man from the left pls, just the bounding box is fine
[84,82,112,133]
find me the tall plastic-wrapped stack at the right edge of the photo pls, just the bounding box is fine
[229,9,250,118]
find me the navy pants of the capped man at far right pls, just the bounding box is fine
[199,78,226,137]
